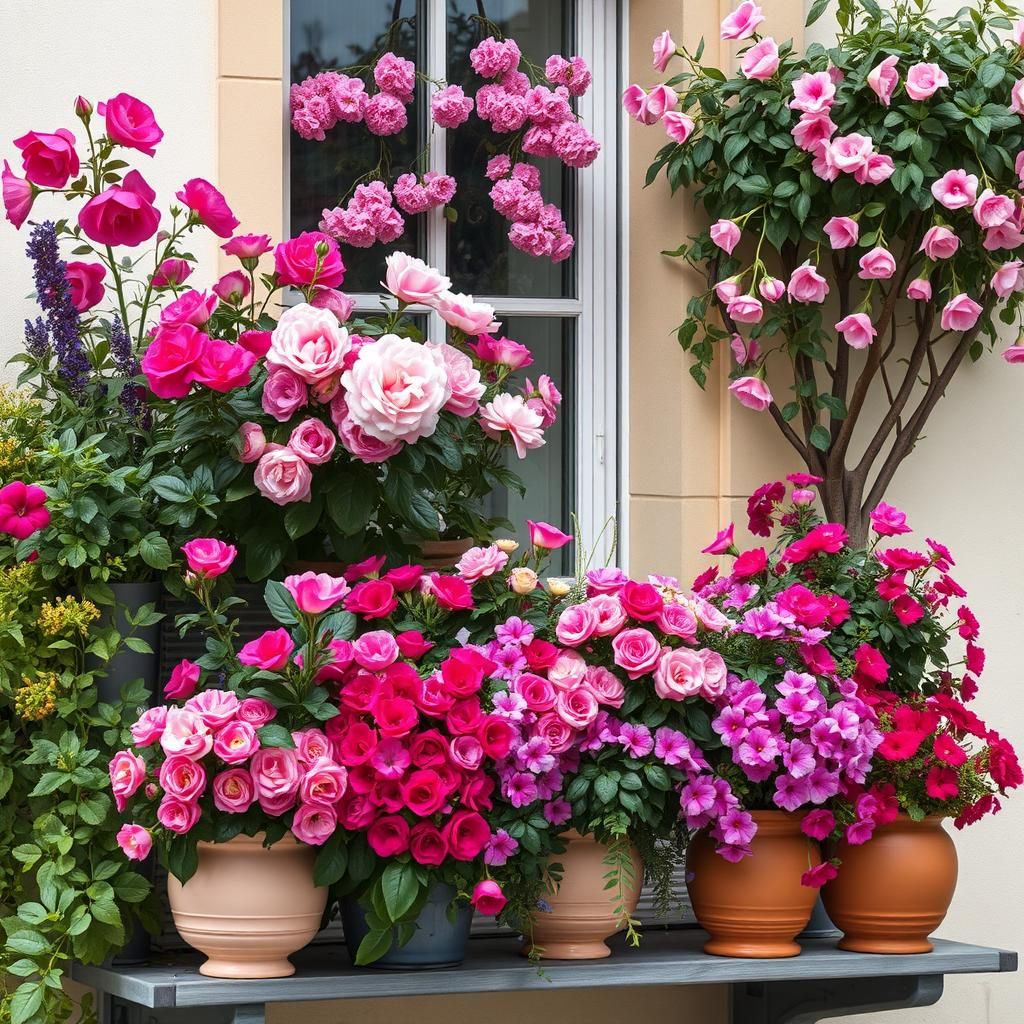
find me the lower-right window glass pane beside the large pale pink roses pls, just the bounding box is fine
[487,314,575,574]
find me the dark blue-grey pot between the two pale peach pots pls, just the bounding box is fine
[341,886,473,971]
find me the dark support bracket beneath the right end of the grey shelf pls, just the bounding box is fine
[729,975,942,1024]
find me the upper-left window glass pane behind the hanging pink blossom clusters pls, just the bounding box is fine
[289,0,426,292]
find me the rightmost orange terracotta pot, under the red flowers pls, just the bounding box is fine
[822,814,956,953]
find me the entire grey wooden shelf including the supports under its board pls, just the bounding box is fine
[73,929,1017,1024]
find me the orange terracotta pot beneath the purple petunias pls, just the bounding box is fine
[686,811,821,959]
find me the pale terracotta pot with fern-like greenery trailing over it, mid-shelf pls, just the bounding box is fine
[523,831,643,959]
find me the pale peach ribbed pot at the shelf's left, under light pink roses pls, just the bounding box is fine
[167,836,327,978]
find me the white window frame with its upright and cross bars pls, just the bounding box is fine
[282,0,628,565]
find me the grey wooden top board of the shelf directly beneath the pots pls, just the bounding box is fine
[73,929,1017,1008]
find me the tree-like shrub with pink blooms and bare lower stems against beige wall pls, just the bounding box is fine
[624,0,1024,547]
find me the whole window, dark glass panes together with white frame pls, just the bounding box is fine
[286,0,622,571]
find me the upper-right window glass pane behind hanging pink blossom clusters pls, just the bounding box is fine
[447,0,575,298]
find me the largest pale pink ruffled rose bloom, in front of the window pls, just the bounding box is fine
[341,334,452,443]
